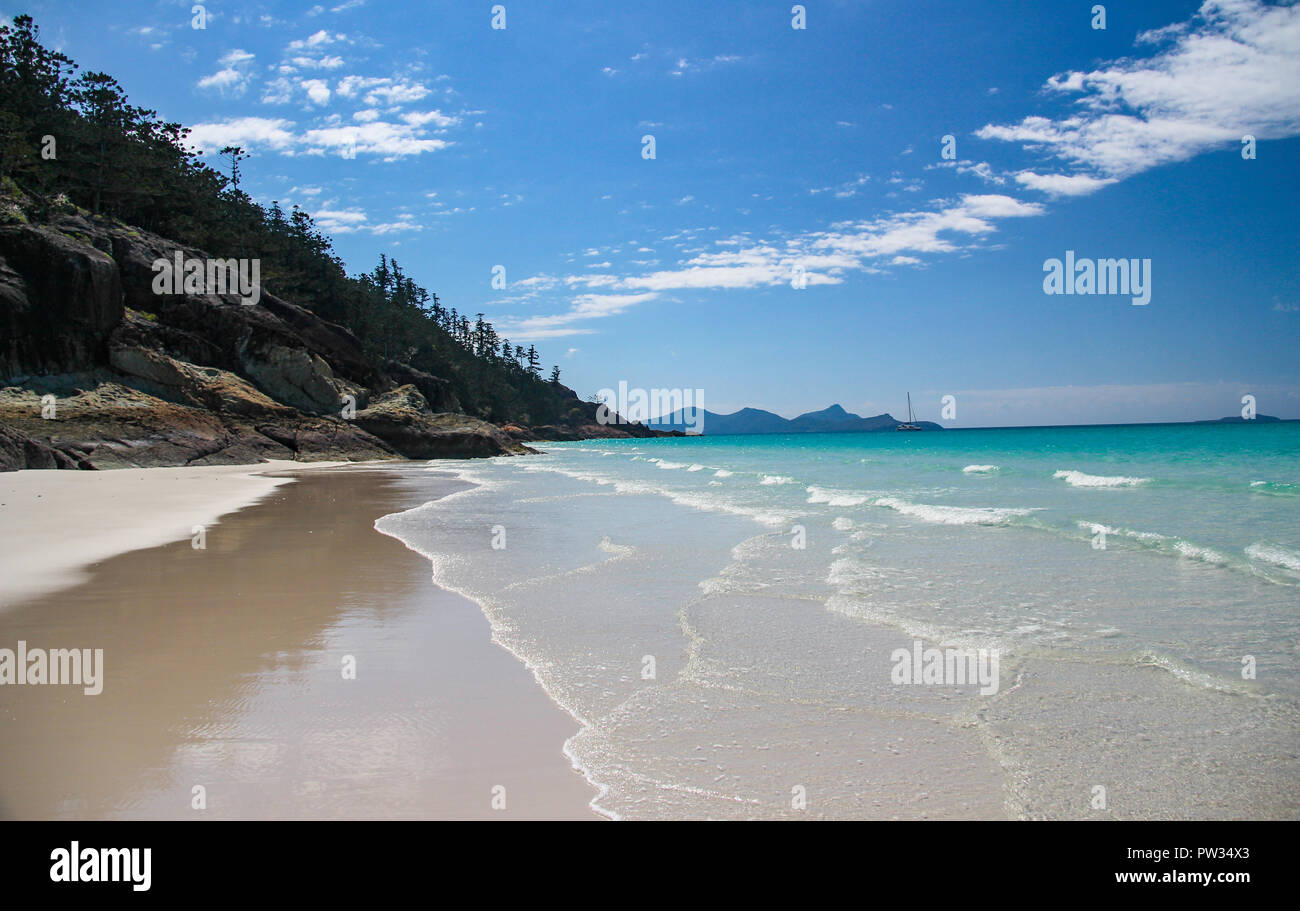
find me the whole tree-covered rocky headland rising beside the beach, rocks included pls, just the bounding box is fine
[0,16,658,468]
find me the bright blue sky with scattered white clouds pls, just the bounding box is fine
[17,0,1300,426]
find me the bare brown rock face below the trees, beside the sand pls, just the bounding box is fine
[0,207,659,470]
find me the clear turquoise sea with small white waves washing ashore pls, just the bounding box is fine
[377,422,1300,819]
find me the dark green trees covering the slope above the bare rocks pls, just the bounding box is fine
[0,16,581,425]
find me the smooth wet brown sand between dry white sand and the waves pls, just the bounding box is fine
[0,464,597,819]
